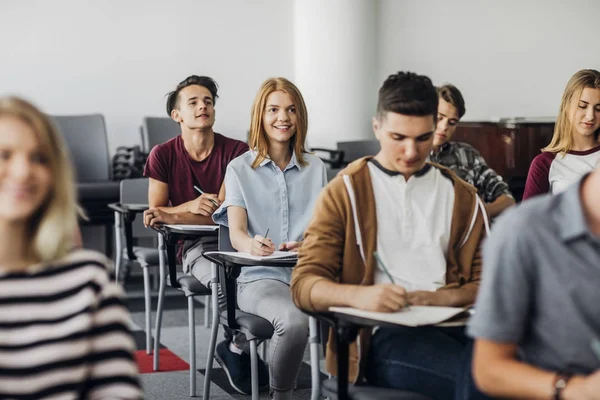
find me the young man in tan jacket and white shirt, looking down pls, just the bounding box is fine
[291,72,487,399]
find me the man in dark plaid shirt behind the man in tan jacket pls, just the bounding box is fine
[429,84,515,218]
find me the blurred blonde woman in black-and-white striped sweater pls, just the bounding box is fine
[0,98,142,399]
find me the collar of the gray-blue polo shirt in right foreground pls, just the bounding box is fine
[556,173,595,242]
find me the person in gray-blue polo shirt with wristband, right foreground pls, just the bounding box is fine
[468,167,600,400]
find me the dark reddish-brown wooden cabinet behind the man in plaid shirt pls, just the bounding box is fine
[452,118,554,200]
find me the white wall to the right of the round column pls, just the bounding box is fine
[379,0,600,119]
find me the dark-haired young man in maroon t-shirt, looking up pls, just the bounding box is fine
[144,75,268,394]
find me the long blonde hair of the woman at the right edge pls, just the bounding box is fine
[542,69,600,153]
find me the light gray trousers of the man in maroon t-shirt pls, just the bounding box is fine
[183,238,250,354]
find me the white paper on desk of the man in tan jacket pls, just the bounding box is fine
[329,306,466,326]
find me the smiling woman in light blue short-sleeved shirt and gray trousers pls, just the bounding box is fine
[213,78,327,400]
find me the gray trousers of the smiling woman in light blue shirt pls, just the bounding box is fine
[238,279,308,392]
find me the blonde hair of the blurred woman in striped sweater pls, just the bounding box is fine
[0,97,80,263]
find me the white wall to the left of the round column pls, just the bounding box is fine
[0,0,293,151]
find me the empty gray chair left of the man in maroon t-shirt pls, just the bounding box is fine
[110,178,160,354]
